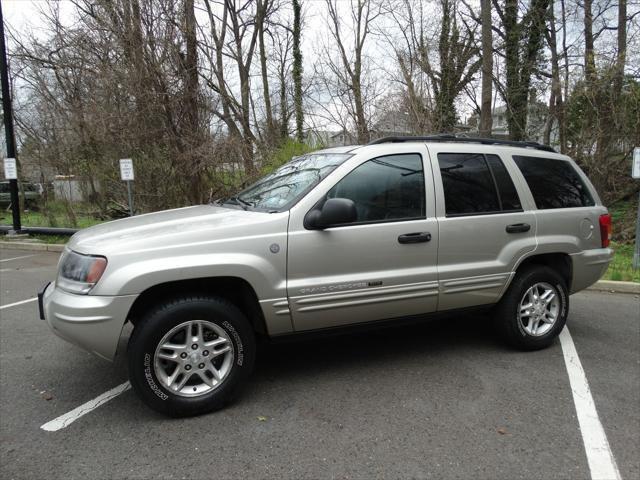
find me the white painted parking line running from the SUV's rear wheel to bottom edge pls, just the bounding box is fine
[560,327,621,480]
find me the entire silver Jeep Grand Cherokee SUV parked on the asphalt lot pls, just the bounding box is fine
[39,136,613,416]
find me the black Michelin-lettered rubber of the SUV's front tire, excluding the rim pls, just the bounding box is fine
[127,295,256,417]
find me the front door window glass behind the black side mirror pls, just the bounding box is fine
[327,154,425,222]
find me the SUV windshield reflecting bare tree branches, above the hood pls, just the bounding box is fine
[221,153,351,211]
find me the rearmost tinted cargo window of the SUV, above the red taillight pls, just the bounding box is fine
[513,155,595,209]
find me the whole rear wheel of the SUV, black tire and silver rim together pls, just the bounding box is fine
[495,265,569,350]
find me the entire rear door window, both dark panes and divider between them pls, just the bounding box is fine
[438,153,522,216]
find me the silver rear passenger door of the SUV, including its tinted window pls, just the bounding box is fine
[429,144,536,310]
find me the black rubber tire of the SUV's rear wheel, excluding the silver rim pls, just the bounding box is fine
[494,265,569,350]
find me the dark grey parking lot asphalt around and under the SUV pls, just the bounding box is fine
[0,250,640,479]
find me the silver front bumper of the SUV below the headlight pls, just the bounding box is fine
[38,283,138,361]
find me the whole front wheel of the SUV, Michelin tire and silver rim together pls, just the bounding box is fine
[128,296,255,416]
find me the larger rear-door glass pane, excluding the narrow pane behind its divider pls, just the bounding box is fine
[438,153,500,215]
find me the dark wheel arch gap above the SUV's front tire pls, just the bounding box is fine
[127,276,267,335]
